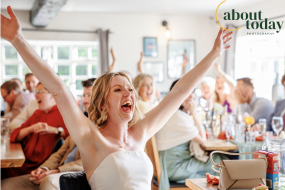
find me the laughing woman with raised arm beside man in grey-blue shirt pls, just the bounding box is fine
[214,63,237,113]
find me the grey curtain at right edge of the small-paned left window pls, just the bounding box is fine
[98,29,110,74]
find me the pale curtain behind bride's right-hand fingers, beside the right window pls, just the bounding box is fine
[224,24,237,78]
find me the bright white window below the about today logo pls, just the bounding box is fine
[235,31,285,100]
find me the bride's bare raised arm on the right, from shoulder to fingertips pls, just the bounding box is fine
[137,29,232,140]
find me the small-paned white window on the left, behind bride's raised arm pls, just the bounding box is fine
[1,40,100,96]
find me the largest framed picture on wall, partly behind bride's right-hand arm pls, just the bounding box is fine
[167,40,196,79]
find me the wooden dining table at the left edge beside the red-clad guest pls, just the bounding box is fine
[1,138,25,168]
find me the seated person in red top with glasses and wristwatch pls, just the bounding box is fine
[2,83,69,179]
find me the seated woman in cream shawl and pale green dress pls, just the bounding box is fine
[156,80,227,189]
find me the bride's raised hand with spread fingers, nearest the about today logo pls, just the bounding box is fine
[213,28,233,58]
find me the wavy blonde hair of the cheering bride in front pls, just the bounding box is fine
[88,72,143,127]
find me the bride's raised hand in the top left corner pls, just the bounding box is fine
[1,6,21,43]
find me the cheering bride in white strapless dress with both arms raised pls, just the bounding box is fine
[1,6,232,190]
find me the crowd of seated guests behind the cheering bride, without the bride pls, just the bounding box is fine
[1,62,280,189]
